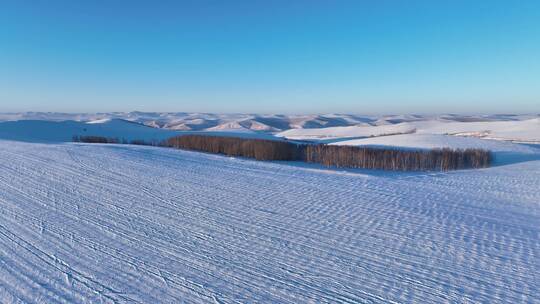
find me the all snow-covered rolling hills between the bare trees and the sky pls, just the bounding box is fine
[0,112,540,154]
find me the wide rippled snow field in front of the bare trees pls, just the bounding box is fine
[0,136,540,303]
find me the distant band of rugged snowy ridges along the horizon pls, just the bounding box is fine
[0,111,540,133]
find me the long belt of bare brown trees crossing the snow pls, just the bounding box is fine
[73,134,492,171]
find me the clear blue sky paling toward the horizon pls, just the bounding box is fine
[0,0,540,114]
